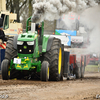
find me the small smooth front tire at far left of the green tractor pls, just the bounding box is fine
[1,59,10,80]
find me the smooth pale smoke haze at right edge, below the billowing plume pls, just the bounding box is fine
[80,5,100,54]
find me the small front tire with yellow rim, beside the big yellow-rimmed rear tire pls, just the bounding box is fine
[41,61,49,81]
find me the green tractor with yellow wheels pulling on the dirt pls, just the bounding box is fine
[1,17,64,81]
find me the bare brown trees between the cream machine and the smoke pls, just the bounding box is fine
[6,0,35,28]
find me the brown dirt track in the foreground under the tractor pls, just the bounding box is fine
[0,73,100,100]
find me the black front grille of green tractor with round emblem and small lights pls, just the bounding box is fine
[17,42,34,54]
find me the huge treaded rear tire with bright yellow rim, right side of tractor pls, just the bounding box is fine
[44,38,62,81]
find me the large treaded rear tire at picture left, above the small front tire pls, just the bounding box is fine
[5,37,17,61]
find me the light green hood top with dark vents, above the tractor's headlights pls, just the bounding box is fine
[17,32,37,41]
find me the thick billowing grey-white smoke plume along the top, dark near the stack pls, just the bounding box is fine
[32,0,98,23]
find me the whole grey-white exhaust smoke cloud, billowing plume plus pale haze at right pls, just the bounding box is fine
[32,0,100,53]
